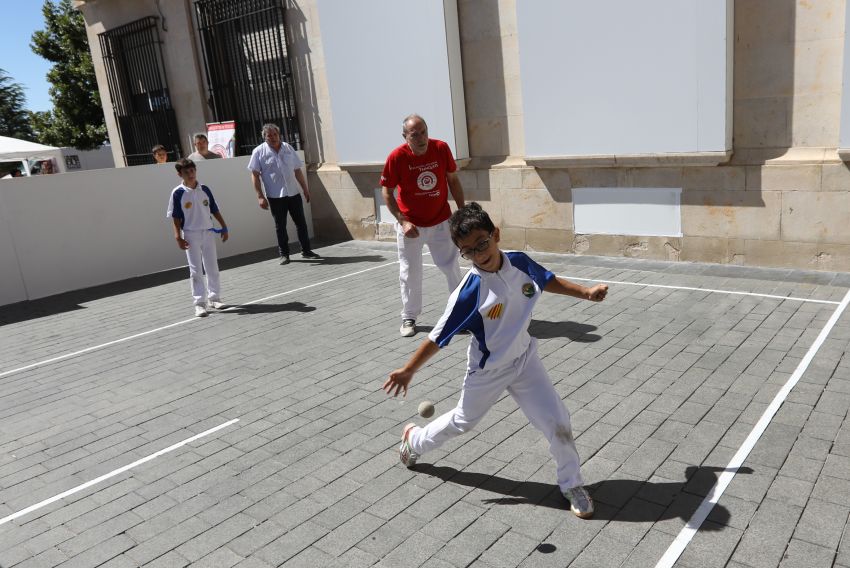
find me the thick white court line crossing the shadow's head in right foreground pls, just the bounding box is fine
[655,291,850,568]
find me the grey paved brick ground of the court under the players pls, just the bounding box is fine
[0,242,850,568]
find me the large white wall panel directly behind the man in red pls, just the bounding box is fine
[317,0,469,165]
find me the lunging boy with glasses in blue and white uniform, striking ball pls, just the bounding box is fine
[383,202,608,518]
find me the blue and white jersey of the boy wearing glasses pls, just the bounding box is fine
[428,251,555,370]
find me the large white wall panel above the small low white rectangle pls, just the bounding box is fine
[517,0,732,157]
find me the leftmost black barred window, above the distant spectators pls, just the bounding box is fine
[98,16,181,166]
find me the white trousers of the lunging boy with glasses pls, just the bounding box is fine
[410,338,584,491]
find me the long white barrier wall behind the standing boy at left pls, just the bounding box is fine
[0,156,313,305]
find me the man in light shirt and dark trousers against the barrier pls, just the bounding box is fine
[248,124,320,264]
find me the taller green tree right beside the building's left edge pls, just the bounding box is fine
[30,0,106,150]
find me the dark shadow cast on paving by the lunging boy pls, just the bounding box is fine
[413,462,753,530]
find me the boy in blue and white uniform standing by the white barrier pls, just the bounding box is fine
[166,158,228,317]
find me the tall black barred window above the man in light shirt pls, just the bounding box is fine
[195,0,301,155]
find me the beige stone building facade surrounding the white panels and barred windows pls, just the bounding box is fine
[75,0,850,271]
